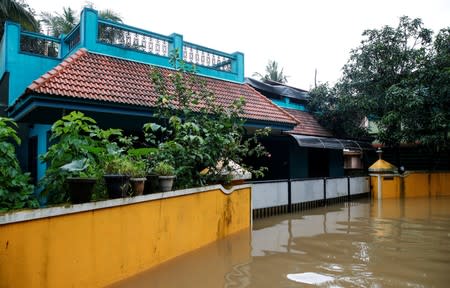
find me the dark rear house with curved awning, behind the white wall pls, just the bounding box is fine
[246,78,373,180]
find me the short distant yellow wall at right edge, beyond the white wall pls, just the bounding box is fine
[370,171,450,199]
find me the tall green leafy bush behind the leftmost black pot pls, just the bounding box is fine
[40,111,122,204]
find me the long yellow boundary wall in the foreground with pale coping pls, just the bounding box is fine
[0,185,251,288]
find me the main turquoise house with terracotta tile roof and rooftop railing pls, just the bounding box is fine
[0,8,297,180]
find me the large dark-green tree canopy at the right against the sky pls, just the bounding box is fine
[310,16,450,150]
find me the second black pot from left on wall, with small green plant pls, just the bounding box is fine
[103,155,132,199]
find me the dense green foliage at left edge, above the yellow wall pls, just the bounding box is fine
[0,117,39,211]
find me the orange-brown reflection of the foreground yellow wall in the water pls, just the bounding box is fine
[107,230,251,288]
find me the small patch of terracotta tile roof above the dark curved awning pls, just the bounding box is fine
[284,108,333,137]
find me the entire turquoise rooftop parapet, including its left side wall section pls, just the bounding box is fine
[0,8,244,105]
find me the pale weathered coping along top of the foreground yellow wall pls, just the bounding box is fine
[0,184,252,226]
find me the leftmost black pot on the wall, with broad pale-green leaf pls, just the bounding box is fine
[61,159,97,204]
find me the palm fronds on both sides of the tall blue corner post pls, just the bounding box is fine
[41,6,122,37]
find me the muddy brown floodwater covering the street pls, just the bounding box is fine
[111,197,450,288]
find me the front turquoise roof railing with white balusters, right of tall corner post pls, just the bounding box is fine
[81,8,244,83]
